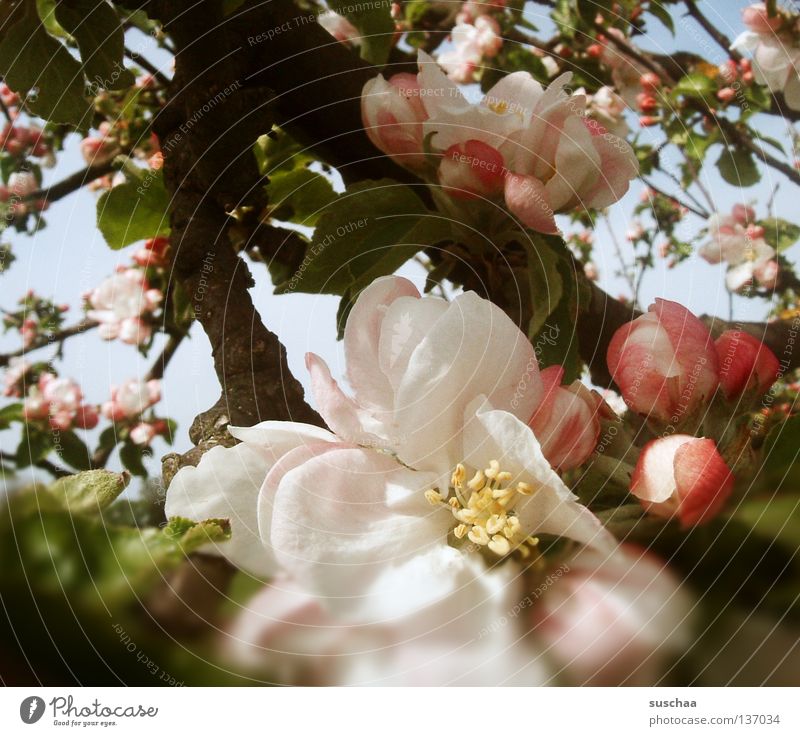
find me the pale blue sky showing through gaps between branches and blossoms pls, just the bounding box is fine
[0,0,800,480]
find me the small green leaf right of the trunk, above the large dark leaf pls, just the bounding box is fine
[267,169,337,227]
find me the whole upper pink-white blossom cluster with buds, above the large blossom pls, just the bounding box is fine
[361,51,638,233]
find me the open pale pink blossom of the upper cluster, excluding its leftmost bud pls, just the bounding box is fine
[394,51,638,232]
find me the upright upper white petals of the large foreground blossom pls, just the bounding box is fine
[306,276,542,476]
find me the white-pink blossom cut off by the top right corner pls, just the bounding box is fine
[731,3,800,110]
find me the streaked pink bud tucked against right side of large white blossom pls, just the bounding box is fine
[528,365,600,470]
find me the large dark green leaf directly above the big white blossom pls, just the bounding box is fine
[276,179,450,296]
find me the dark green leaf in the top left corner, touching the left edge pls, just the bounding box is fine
[0,3,91,130]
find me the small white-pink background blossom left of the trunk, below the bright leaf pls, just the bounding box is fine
[87,268,163,345]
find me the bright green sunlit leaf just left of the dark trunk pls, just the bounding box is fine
[97,166,169,250]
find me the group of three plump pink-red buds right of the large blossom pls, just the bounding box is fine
[608,299,780,526]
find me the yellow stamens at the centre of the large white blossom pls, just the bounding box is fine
[425,460,539,559]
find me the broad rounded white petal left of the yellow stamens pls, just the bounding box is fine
[270,442,452,620]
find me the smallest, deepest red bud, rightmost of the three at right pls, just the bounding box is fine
[714,330,780,398]
